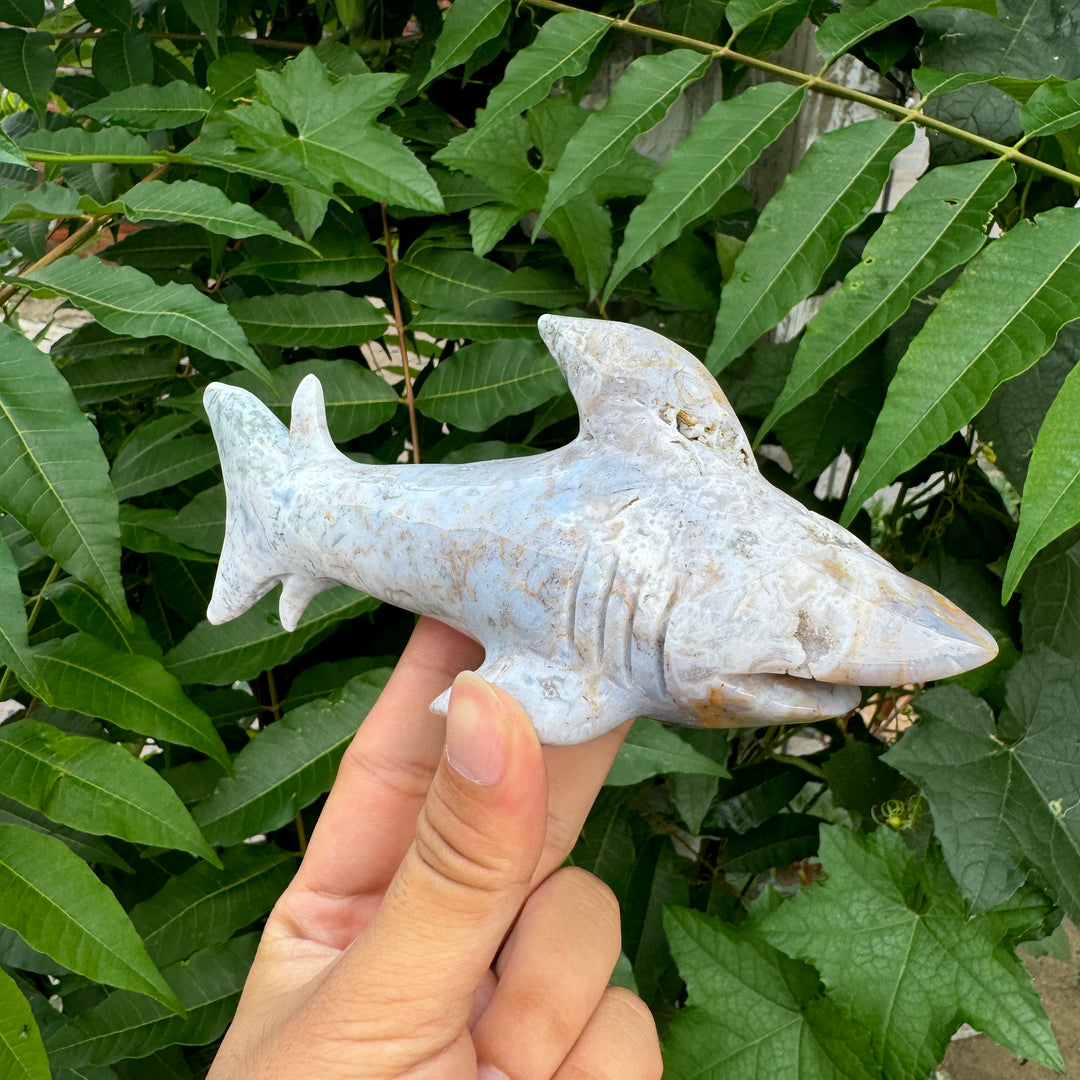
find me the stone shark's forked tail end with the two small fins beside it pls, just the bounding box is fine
[203,375,337,630]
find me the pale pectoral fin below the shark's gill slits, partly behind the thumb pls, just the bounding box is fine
[431,654,635,746]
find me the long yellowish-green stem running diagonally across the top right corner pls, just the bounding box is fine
[525,0,1080,187]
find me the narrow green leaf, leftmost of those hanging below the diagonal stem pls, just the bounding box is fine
[440,9,608,160]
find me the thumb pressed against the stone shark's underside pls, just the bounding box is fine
[349,672,548,1025]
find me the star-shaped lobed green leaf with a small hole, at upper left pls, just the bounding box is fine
[227,49,443,213]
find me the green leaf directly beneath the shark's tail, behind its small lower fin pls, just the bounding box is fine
[159,585,379,686]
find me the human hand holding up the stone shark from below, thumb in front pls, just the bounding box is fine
[208,619,662,1080]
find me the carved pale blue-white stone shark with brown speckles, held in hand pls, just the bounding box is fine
[204,315,997,743]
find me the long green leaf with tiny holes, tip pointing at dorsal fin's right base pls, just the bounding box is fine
[757,161,1014,440]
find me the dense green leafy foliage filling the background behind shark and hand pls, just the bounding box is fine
[0,0,1080,1080]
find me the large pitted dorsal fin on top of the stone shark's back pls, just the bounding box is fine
[540,315,757,470]
